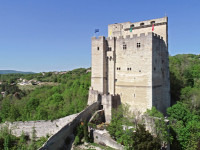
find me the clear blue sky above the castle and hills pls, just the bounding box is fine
[0,0,200,72]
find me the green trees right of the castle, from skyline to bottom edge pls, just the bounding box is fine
[167,54,200,150]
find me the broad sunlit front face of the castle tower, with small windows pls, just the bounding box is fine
[115,33,153,112]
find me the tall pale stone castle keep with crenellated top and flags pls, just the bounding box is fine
[88,17,170,120]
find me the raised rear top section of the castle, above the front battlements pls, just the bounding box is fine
[108,17,168,44]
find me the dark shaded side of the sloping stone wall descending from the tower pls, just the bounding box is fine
[39,101,100,150]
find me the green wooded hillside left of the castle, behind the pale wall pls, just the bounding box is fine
[0,69,90,122]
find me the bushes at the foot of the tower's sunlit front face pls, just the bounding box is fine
[107,105,161,150]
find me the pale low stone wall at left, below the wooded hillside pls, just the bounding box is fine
[0,114,78,138]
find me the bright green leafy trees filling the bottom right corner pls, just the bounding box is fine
[167,102,200,150]
